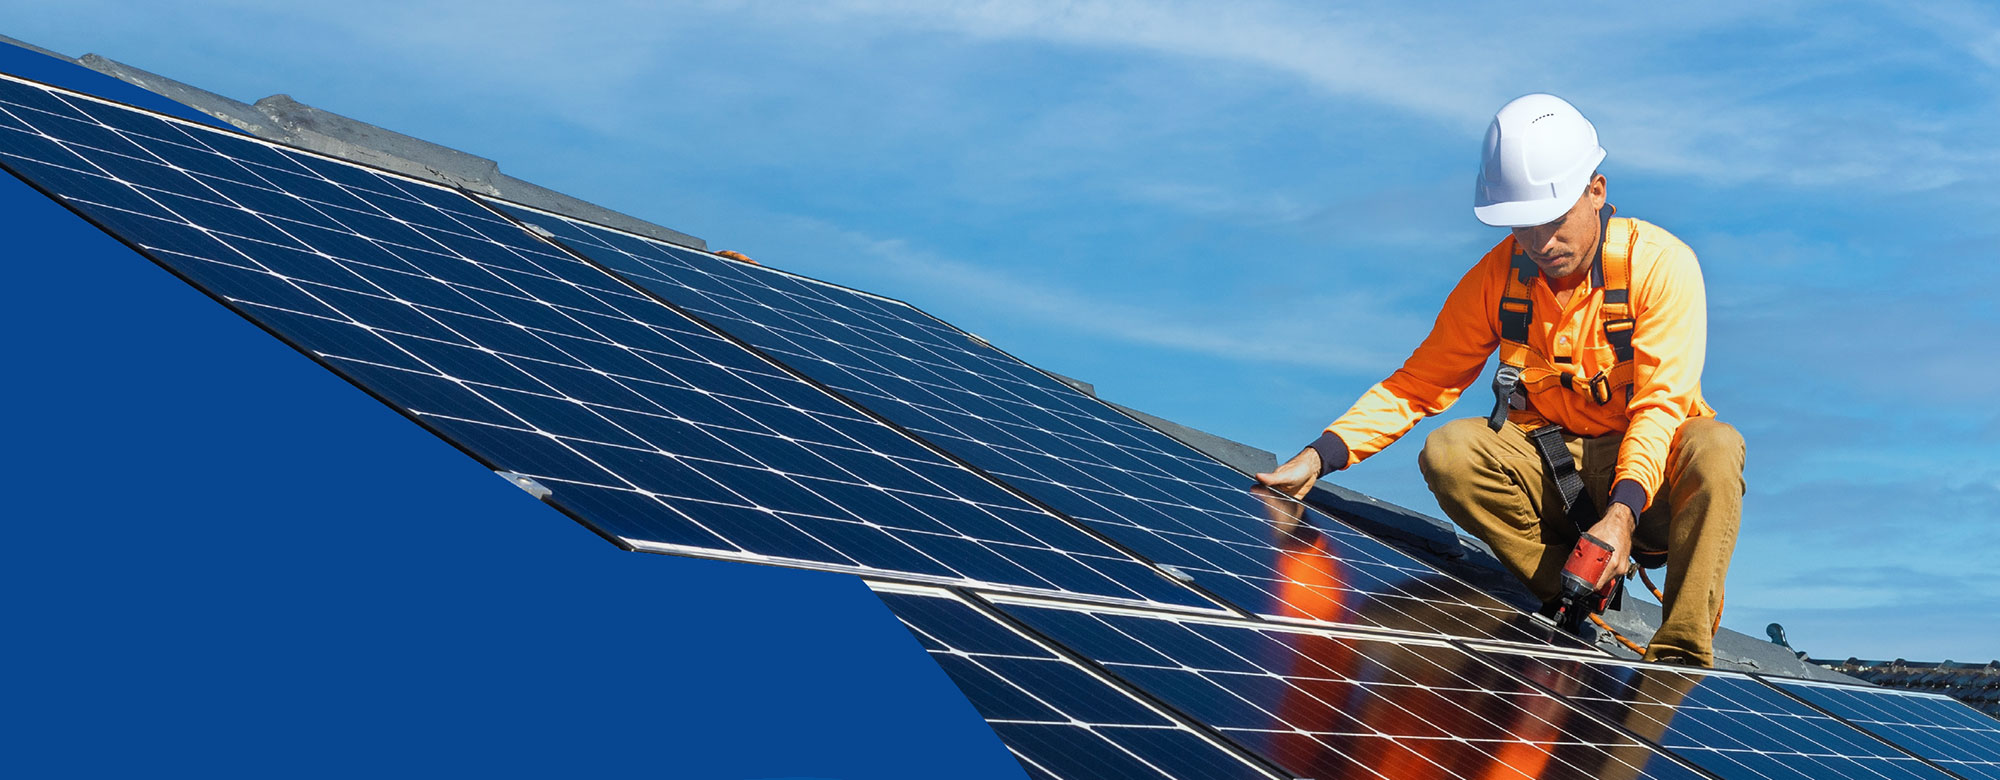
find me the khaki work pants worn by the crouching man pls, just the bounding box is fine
[1418,418,1744,666]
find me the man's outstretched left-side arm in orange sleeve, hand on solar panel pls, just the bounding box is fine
[1256,247,1512,496]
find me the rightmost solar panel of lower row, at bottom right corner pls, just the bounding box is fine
[1768,680,2000,780]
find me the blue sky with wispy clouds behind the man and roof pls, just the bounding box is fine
[0,0,2000,660]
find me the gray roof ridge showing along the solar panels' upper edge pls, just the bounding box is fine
[0,36,1854,682]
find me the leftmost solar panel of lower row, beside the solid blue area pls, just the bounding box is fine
[870,582,1272,780]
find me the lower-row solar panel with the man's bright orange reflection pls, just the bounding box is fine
[992,598,1700,780]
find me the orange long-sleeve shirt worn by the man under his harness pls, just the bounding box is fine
[1314,220,1716,514]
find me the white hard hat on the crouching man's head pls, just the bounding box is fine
[1472,94,1604,228]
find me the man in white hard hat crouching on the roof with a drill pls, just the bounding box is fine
[1258,94,1744,666]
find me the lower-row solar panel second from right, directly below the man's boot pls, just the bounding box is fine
[1486,652,1948,780]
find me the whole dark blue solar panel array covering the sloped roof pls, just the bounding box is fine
[0,70,1976,780]
